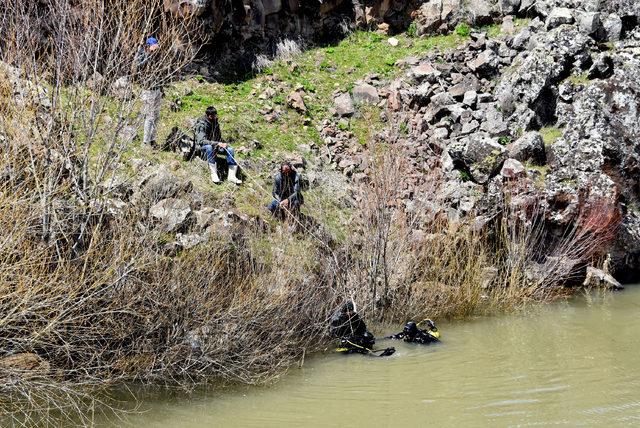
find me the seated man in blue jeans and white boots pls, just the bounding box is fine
[195,107,242,184]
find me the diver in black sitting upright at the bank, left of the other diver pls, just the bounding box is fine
[330,300,396,357]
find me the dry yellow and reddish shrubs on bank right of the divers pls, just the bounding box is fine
[336,145,620,322]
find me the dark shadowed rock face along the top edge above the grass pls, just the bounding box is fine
[170,0,416,78]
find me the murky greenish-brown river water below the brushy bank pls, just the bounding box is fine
[105,286,640,428]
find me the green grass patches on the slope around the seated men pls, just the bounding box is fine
[112,26,516,234]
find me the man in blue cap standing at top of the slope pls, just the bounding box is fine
[136,37,162,148]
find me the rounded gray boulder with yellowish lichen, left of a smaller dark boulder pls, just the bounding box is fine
[463,134,507,184]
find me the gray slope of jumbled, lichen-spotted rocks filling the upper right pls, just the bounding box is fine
[320,0,640,279]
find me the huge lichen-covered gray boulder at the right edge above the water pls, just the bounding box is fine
[546,48,640,270]
